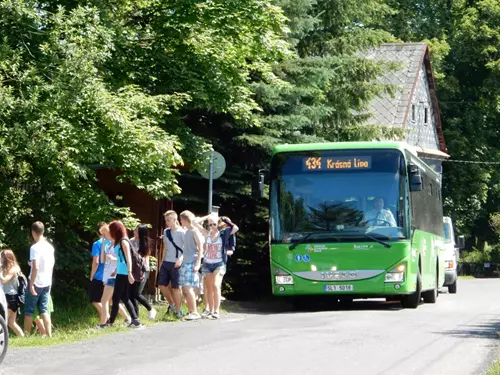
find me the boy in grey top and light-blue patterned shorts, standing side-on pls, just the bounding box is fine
[179,211,203,320]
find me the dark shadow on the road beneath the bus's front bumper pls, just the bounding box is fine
[222,298,402,315]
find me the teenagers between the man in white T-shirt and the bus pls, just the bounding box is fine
[89,210,238,328]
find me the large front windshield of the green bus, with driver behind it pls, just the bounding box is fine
[270,150,408,243]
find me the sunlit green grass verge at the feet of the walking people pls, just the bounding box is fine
[9,302,189,348]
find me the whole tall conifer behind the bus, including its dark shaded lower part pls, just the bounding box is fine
[175,0,404,297]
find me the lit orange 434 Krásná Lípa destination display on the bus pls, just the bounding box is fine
[302,156,372,171]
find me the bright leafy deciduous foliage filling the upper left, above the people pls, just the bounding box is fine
[0,0,288,295]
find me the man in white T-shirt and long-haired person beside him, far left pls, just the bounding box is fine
[0,221,55,337]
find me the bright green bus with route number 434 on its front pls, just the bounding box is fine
[269,142,445,308]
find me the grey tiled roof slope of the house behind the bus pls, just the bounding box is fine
[364,43,427,127]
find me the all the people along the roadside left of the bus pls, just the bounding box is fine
[0,210,238,337]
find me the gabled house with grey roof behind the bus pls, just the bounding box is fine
[365,43,449,174]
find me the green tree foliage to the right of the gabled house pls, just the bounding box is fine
[386,0,500,250]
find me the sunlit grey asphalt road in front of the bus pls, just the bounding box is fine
[0,280,500,375]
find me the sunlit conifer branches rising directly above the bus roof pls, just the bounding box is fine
[243,0,402,153]
